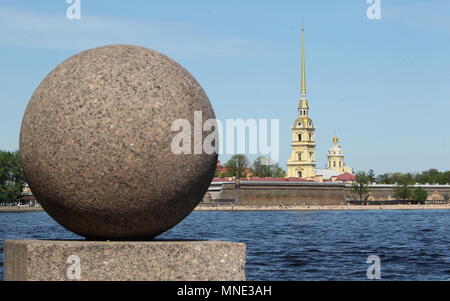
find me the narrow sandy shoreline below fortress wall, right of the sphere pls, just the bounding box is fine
[194,204,450,211]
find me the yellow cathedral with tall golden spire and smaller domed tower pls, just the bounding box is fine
[286,26,352,179]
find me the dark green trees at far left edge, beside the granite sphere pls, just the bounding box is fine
[0,150,25,203]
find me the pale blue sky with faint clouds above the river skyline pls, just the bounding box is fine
[0,0,450,173]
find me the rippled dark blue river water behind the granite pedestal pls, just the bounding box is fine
[0,210,450,280]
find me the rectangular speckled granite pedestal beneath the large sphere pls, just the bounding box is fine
[4,240,246,281]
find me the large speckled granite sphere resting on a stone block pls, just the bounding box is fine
[20,45,217,239]
